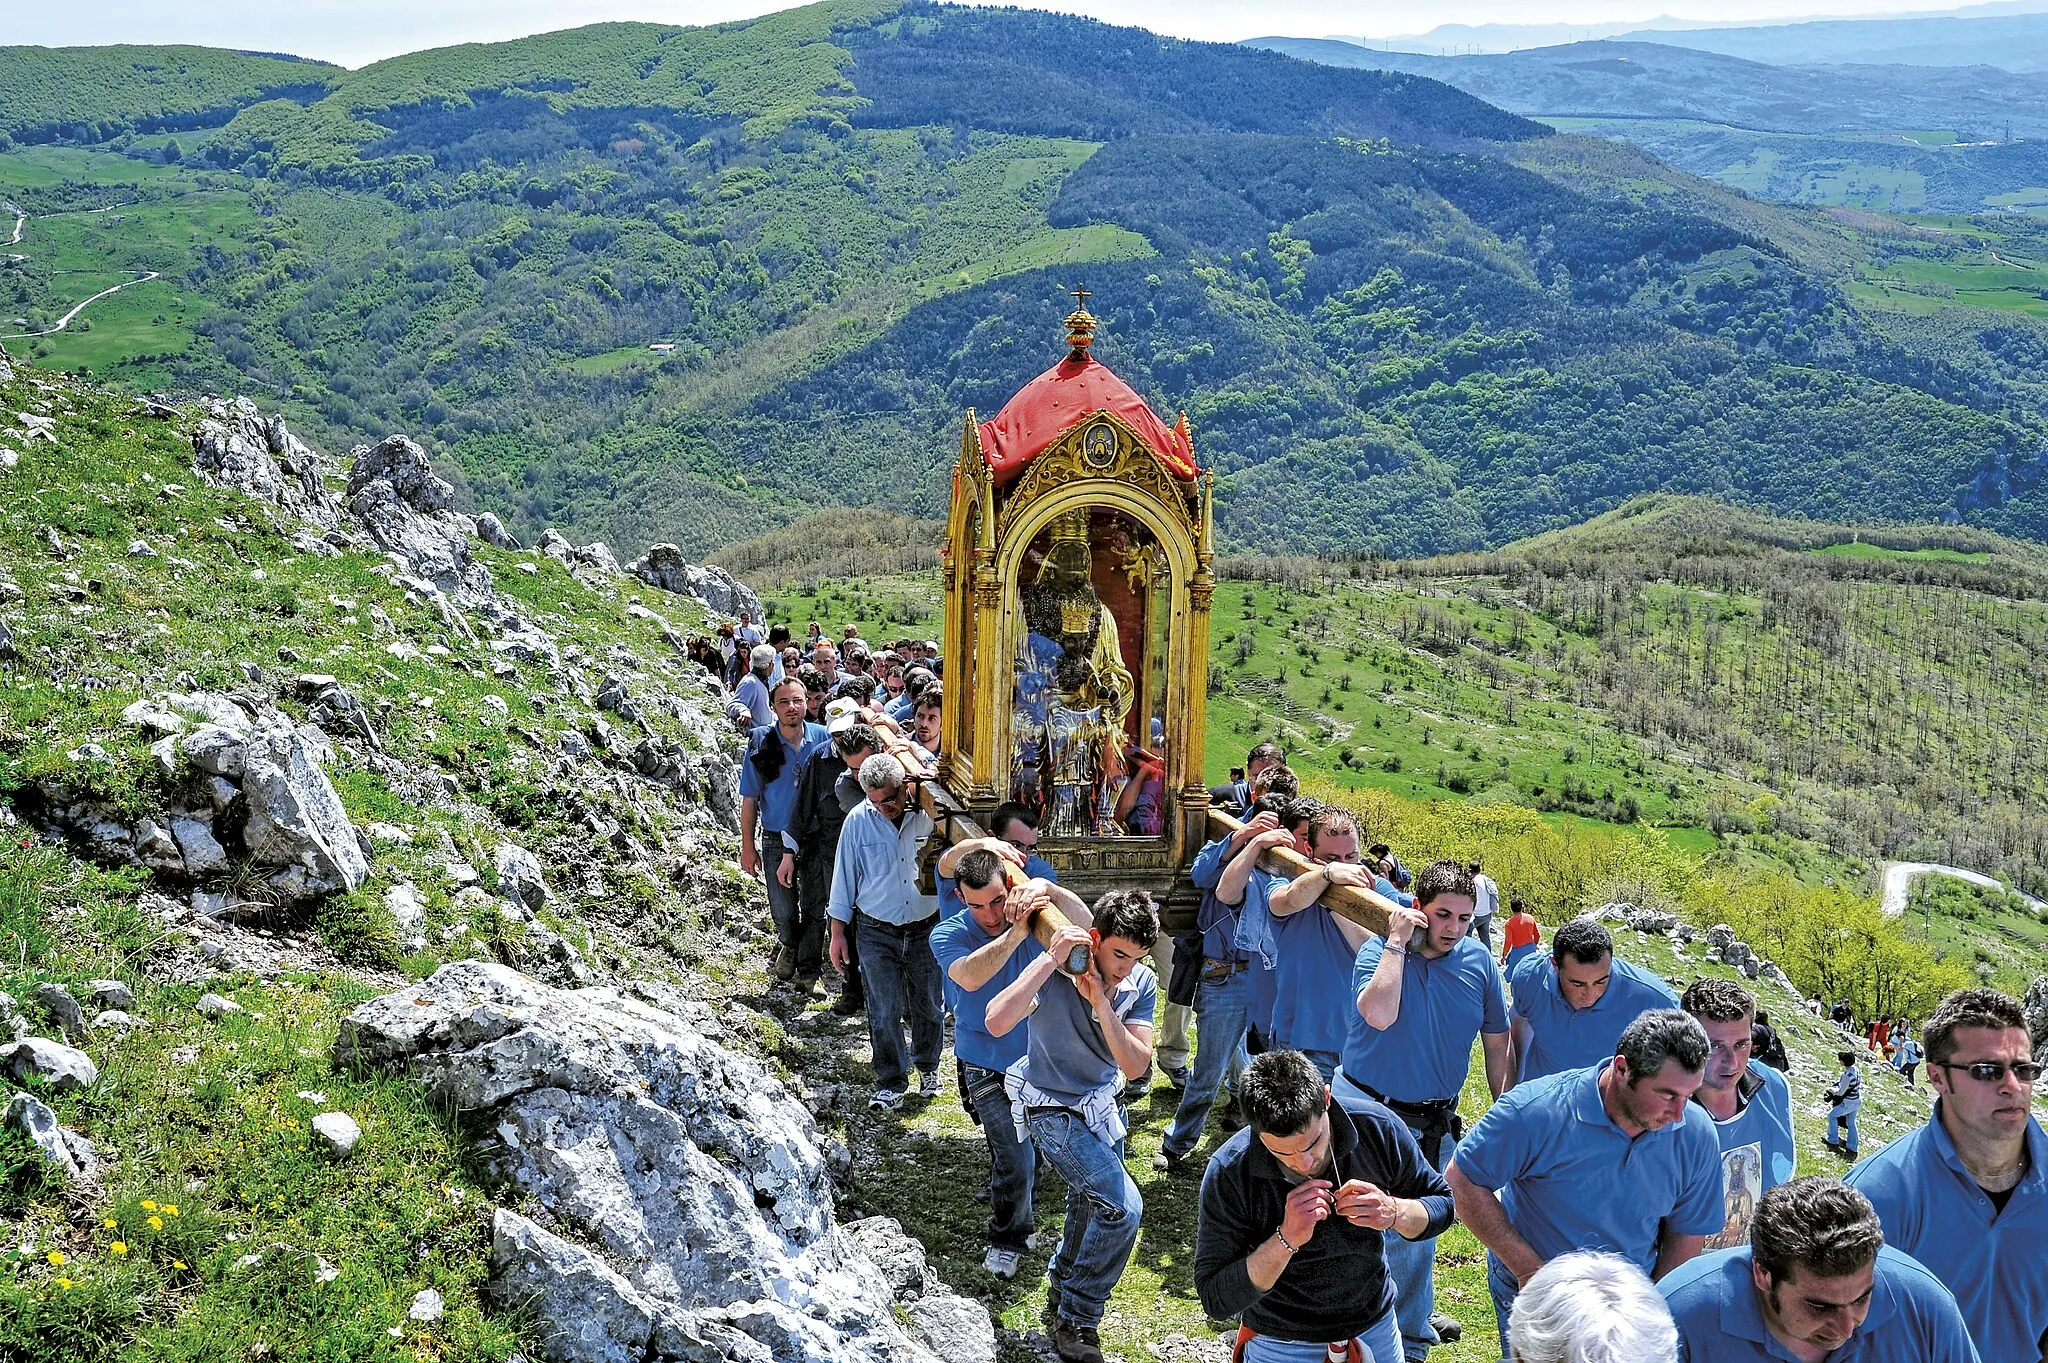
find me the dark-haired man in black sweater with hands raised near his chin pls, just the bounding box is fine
[1194,1050,1452,1363]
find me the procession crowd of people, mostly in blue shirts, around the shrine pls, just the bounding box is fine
[707,620,2048,1363]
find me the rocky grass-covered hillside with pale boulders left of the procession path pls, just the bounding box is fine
[0,341,993,1363]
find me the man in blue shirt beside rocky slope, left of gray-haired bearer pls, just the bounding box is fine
[739,677,831,980]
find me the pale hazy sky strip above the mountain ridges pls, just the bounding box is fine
[0,0,2015,65]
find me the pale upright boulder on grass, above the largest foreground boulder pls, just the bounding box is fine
[242,712,371,900]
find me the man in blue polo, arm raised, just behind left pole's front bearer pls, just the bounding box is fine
[932,839,1087,1279]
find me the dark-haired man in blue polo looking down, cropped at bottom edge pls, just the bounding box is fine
[1659,1179,1982,1363]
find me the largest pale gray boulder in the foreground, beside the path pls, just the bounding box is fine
[336,960,934,1363]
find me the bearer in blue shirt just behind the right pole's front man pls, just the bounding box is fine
[1266,806,1374,1083]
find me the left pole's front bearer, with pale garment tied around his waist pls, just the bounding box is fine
[987,890,1159,1363]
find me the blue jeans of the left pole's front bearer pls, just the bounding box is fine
[1026,1107,1145,1330]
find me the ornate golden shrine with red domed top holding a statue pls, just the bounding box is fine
[940,289,1217,900]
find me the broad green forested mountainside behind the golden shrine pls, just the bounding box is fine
[12,0,2048,553]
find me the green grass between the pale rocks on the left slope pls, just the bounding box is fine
[0,356,765,1363]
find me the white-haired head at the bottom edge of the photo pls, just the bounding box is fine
[1507,1250,1677,1363]
